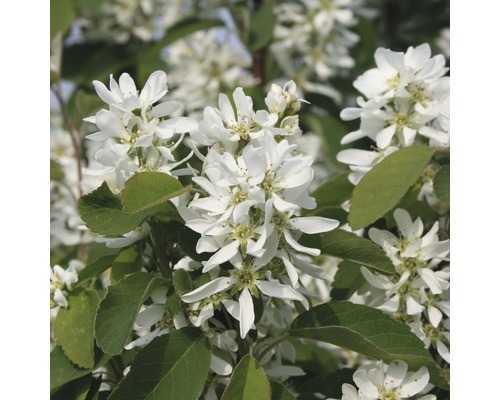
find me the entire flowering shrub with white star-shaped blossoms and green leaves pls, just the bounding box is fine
[50,0,451,400]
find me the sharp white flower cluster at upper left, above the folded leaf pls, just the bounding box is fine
[85,71,197,189]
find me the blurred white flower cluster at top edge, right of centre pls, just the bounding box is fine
[271,0,366,102]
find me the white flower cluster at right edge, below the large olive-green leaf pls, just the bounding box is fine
[361,209,450,363]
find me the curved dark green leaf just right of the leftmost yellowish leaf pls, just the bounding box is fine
[95,272,166,355]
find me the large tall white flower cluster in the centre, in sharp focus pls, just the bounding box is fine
[178,82,338,338]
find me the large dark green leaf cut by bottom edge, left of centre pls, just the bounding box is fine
[109,328,212,400]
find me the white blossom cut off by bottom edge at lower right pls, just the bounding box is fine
[342,360,436,400]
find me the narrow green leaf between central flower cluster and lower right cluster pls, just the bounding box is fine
[300,229,394,274]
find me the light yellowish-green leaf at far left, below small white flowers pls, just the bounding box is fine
[54,288,99,368]
